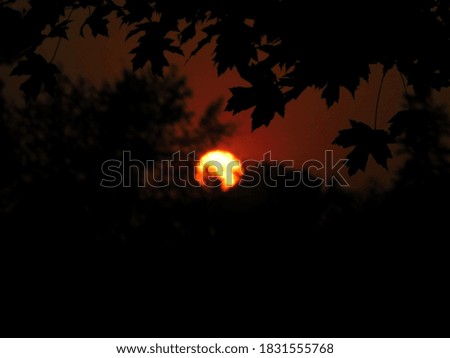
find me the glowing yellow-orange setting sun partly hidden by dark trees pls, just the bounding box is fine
[195,150,242,191]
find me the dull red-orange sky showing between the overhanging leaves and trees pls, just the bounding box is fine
[1,13,444,188]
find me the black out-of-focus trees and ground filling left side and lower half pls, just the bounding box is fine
[0,73,450,337]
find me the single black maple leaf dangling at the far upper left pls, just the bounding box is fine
[11,53,60,101]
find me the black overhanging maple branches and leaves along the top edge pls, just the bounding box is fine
[0,0,450,172]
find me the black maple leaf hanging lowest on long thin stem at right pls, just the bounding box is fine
[333,120,392,175]
